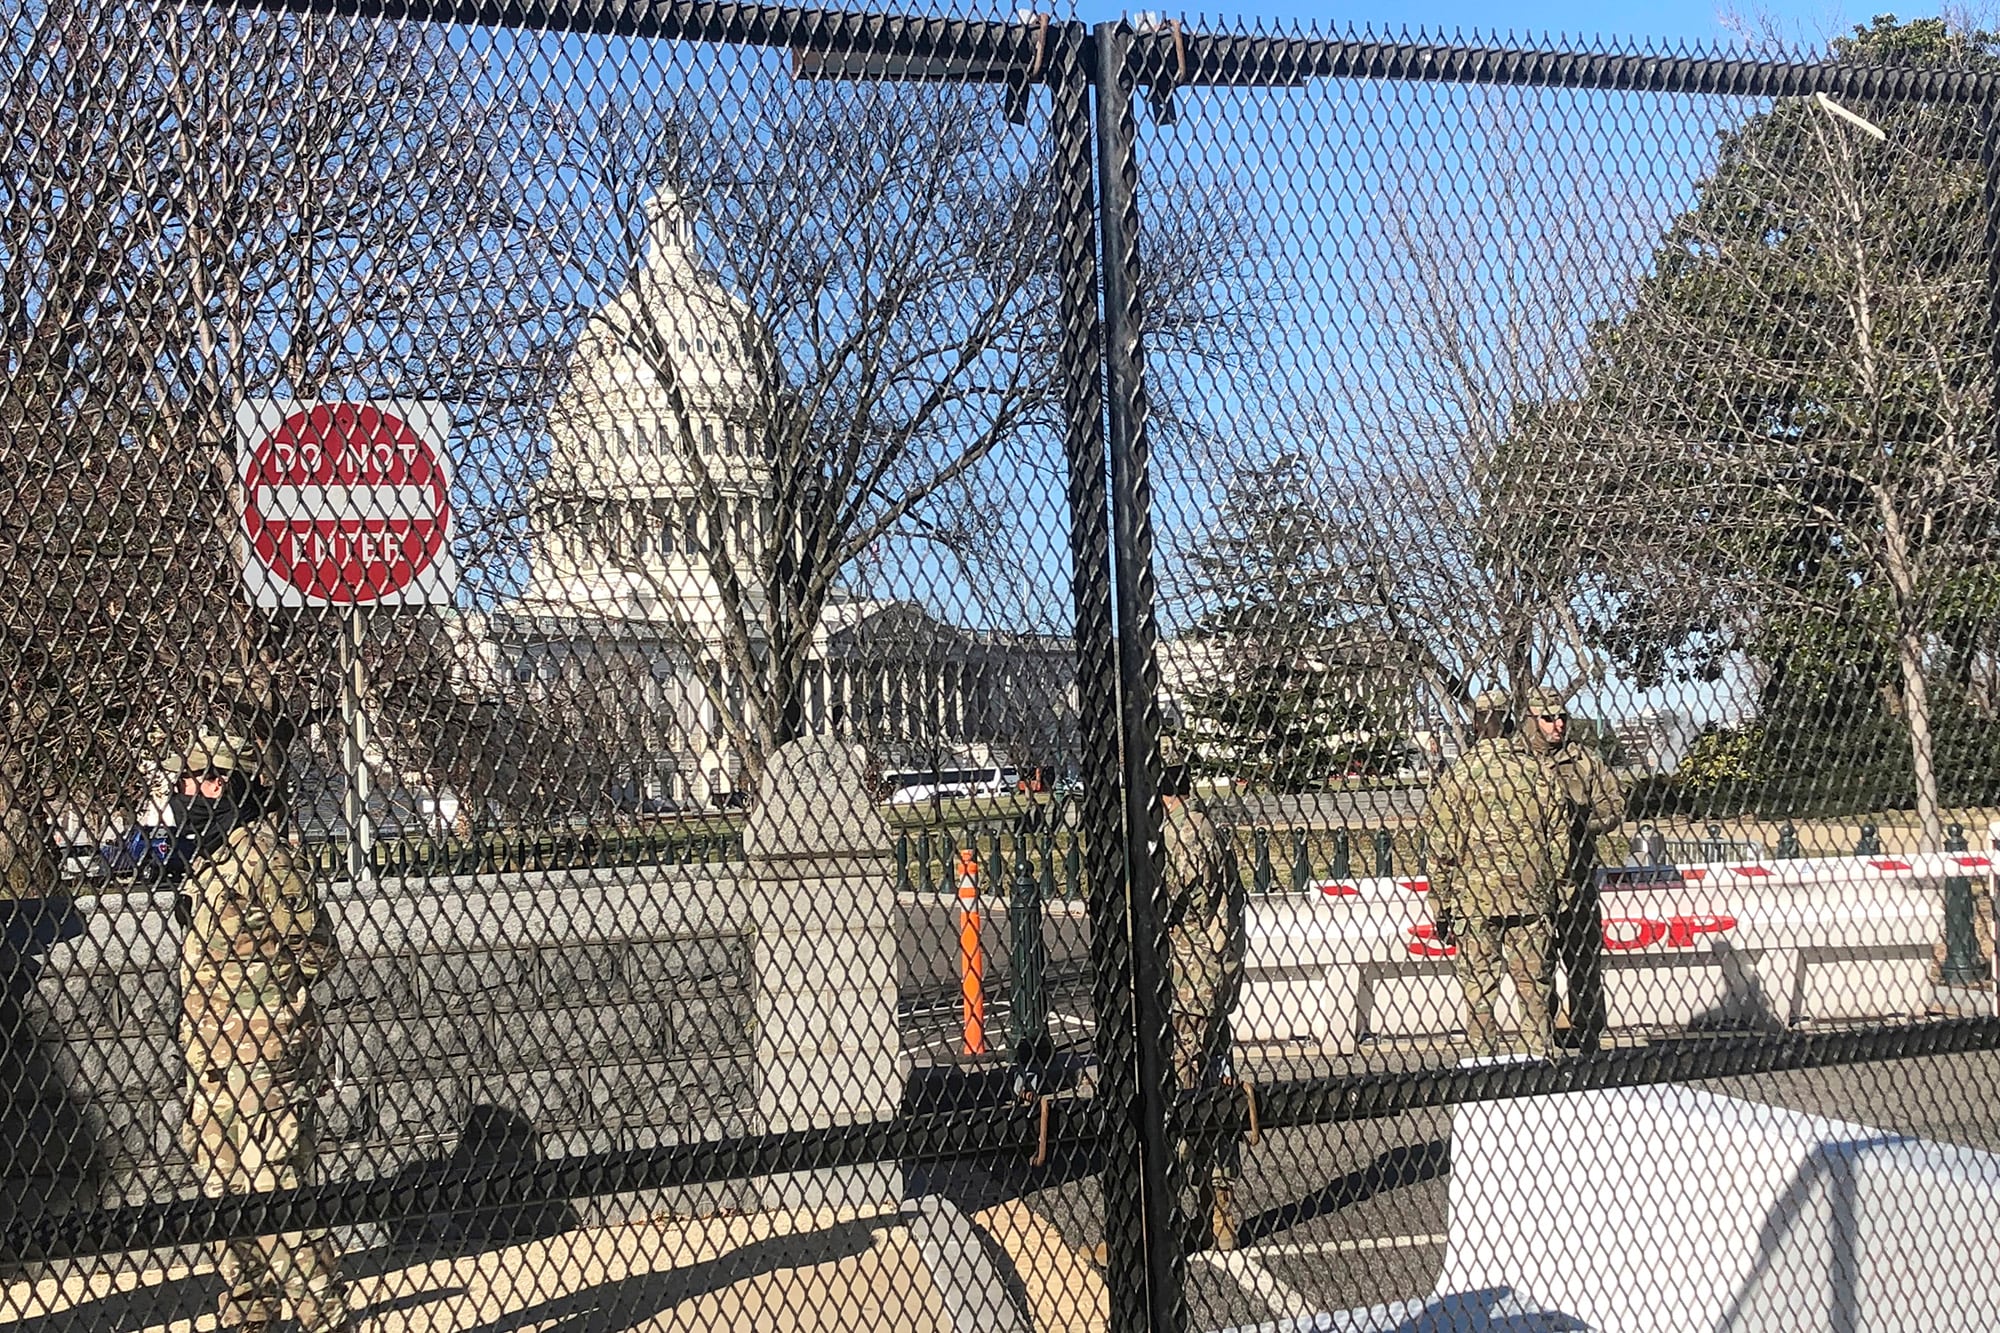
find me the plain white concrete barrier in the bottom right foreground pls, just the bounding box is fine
[1434,1085,2000,1333]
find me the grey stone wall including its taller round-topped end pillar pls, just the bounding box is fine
[13,741,904,1217]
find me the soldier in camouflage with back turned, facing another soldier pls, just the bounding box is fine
[1424,693,1564,1059]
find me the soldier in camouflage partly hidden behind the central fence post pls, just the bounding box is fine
[1160,739,1244,1249]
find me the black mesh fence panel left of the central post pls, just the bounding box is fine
[0,0,1136,1329]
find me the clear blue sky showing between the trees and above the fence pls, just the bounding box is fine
[442,0,1932,719]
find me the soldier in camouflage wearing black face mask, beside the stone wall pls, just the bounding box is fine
[168,737,348,1333]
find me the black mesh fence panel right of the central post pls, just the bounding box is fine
[1134,20,2000,1329]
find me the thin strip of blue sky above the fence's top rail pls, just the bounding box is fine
[1080,0,1888,46]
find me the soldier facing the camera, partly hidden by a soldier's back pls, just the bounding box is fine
[1520,691,1624,1051]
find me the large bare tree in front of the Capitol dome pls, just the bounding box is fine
[544,84,1246,785]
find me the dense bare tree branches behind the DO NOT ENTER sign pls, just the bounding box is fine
[0,0,574,832]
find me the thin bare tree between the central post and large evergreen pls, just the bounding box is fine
[1184,90,1634,727]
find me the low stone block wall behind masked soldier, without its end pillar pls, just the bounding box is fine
[36,867,760,1201]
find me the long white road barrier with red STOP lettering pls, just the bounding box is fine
[1236,853,1952,1051]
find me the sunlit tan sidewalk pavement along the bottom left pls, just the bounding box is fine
[0,1197,1106,1333]
